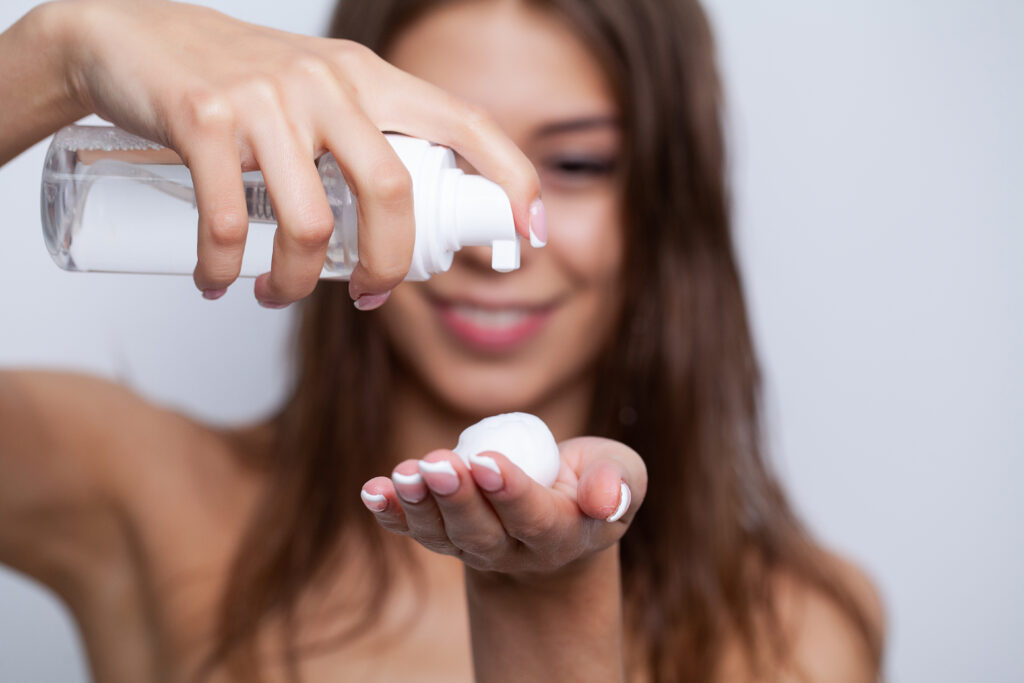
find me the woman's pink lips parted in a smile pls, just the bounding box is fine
[433,299,553,353]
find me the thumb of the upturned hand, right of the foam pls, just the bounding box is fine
[559,437,647,525]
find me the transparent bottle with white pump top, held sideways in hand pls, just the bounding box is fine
[40,126,519,280]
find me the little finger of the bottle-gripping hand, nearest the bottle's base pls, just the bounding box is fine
[182,126,249,299]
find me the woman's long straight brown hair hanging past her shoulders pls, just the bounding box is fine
[203,0,882,682]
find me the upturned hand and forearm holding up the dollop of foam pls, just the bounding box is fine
[362,437,647,683]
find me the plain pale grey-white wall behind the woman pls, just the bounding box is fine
[0,0,1024,683]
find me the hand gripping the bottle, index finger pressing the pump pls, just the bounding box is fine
[0,0,539,308]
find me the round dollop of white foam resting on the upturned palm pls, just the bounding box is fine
[455,413,560,486]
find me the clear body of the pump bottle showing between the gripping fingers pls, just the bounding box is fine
[41,126,358,279]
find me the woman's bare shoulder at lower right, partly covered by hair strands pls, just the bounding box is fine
[720,551,886,683]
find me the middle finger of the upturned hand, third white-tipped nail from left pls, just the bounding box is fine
[419,451,511,568]
